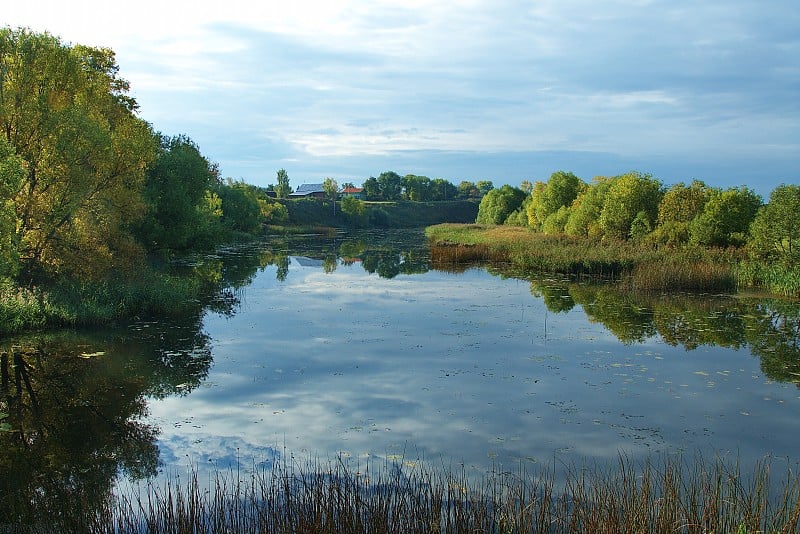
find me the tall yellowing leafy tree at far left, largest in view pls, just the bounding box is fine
[0,28,155,276]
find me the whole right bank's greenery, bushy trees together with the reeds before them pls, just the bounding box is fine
[427,172,800,297]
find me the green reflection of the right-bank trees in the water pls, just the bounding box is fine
[531,280,800,386]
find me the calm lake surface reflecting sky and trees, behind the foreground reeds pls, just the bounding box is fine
[0,231,800,506]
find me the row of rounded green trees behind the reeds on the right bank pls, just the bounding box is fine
[476,171,800,263]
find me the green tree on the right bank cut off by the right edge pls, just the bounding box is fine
[750,184,800,265]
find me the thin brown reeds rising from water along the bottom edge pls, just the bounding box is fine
[15,456,800,534]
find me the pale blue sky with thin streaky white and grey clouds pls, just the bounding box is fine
[0,0,800,195]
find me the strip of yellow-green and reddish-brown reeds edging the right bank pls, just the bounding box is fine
[426,224,752,291]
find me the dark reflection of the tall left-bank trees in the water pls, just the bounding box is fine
[0,319,211,528]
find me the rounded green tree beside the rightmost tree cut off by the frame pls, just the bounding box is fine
[690,187,761,247]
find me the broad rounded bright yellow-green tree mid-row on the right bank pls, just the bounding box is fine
[598,172,663,239]
